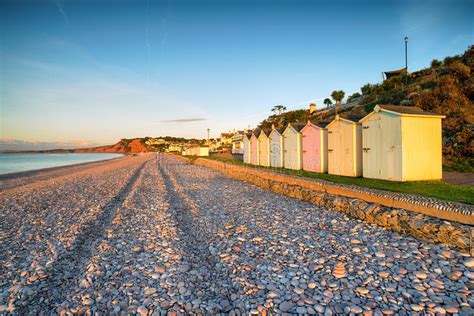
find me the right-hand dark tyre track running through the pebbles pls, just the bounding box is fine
[158,158,238,313]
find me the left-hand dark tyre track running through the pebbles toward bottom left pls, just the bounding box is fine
[18,160,150,315]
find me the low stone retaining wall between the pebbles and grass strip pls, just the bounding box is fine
[191,158,474,254]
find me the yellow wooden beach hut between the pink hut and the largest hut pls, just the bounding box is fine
[326,115,362,177]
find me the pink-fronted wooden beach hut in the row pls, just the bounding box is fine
[301,121,328,172]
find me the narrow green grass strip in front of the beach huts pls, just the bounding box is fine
[201,157,474,204]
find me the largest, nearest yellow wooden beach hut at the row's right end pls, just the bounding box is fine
[360,105,445,181]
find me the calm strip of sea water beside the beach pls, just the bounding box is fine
[0,154,123,174]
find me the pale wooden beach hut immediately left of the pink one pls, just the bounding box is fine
[283,123,306,170]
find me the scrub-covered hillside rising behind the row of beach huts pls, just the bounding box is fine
[259,46,474,170]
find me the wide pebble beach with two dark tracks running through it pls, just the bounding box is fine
[0,154,474,316]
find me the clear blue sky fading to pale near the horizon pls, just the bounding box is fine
[0,0,474,147]
